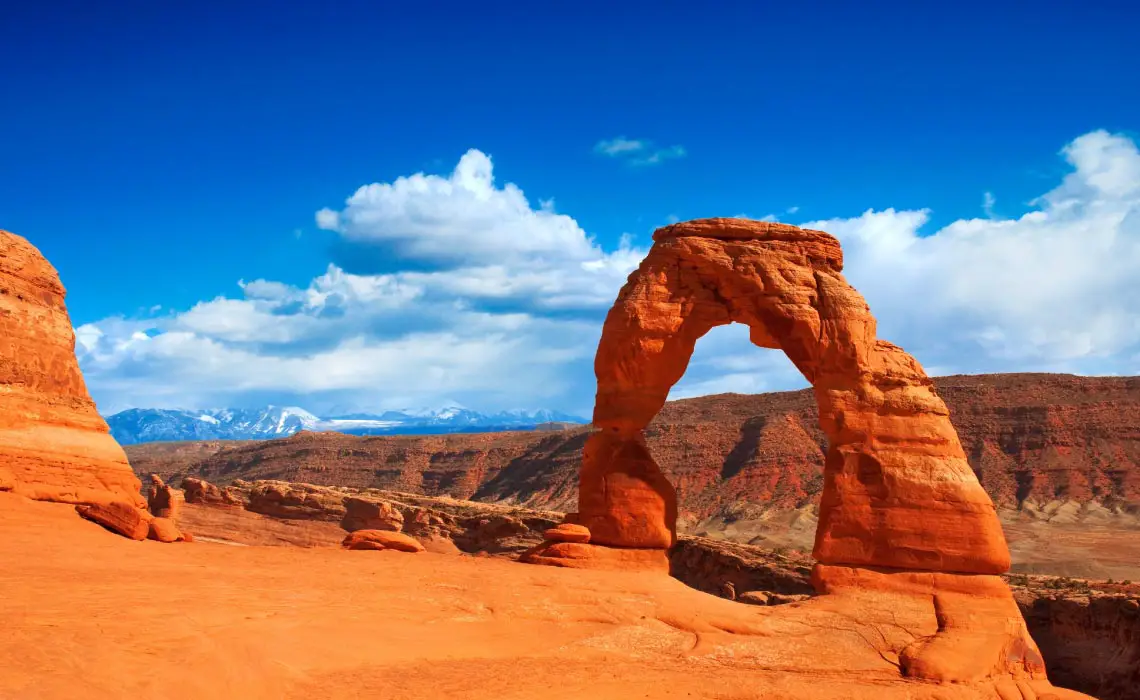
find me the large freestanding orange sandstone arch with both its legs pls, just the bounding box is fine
[578,219,1009,573]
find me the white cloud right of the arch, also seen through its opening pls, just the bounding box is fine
[675,131,1140,396]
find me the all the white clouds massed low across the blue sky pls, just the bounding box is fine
[76,131,1140,414]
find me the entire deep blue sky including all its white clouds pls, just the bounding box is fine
[0,1,1140,413]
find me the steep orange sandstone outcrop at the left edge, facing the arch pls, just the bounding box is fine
[0,230,144,505]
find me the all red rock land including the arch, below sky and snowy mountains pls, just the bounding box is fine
[0,219,1140,700]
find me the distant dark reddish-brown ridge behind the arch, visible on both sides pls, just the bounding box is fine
[128,374,1140,521]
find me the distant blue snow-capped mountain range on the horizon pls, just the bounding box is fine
[107,406,588,445]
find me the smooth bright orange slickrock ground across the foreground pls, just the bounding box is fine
[0,494,1085,700]
